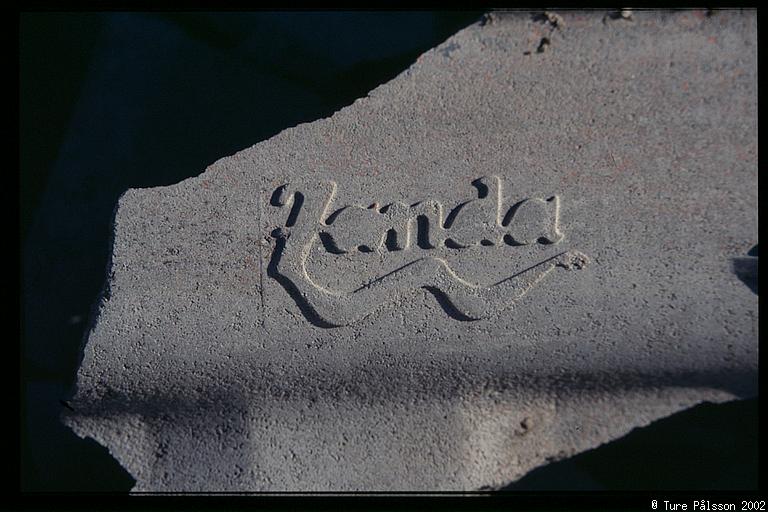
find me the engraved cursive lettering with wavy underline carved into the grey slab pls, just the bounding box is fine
[268,176,589,327]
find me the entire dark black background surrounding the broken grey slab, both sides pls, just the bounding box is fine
[19,11,758,491]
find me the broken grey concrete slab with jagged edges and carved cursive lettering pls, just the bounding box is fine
[63,11,758,491]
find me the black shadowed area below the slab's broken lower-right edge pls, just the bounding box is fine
[501,398,759,492]
